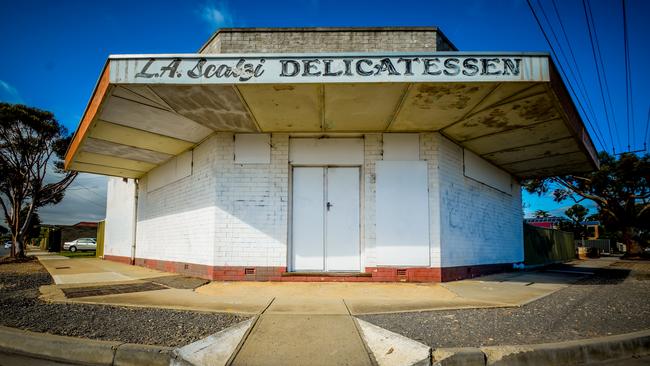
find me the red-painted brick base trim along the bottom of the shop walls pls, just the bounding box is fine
[104,255,512,282]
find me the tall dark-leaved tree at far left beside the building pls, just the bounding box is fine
[0,103,77,257]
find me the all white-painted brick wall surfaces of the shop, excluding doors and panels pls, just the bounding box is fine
[106,133,523,267]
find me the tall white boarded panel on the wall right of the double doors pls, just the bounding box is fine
[376,161,430,266]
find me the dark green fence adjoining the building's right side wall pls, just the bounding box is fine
[524,224,576,265]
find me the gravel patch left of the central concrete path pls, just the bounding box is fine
[0,261,246,347]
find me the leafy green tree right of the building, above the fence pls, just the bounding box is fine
[524,152,650,254]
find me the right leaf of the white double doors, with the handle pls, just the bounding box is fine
[325,168,361,271]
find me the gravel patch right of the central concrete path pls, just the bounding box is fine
[361,265,650,348]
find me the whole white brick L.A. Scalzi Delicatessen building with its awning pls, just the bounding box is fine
[66,28,596,281]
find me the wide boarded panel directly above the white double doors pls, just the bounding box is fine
[289,138,363,165]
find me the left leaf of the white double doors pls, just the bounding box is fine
[292,168,325,271]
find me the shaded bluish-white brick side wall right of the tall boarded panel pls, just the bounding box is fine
[434,134,523,267]
